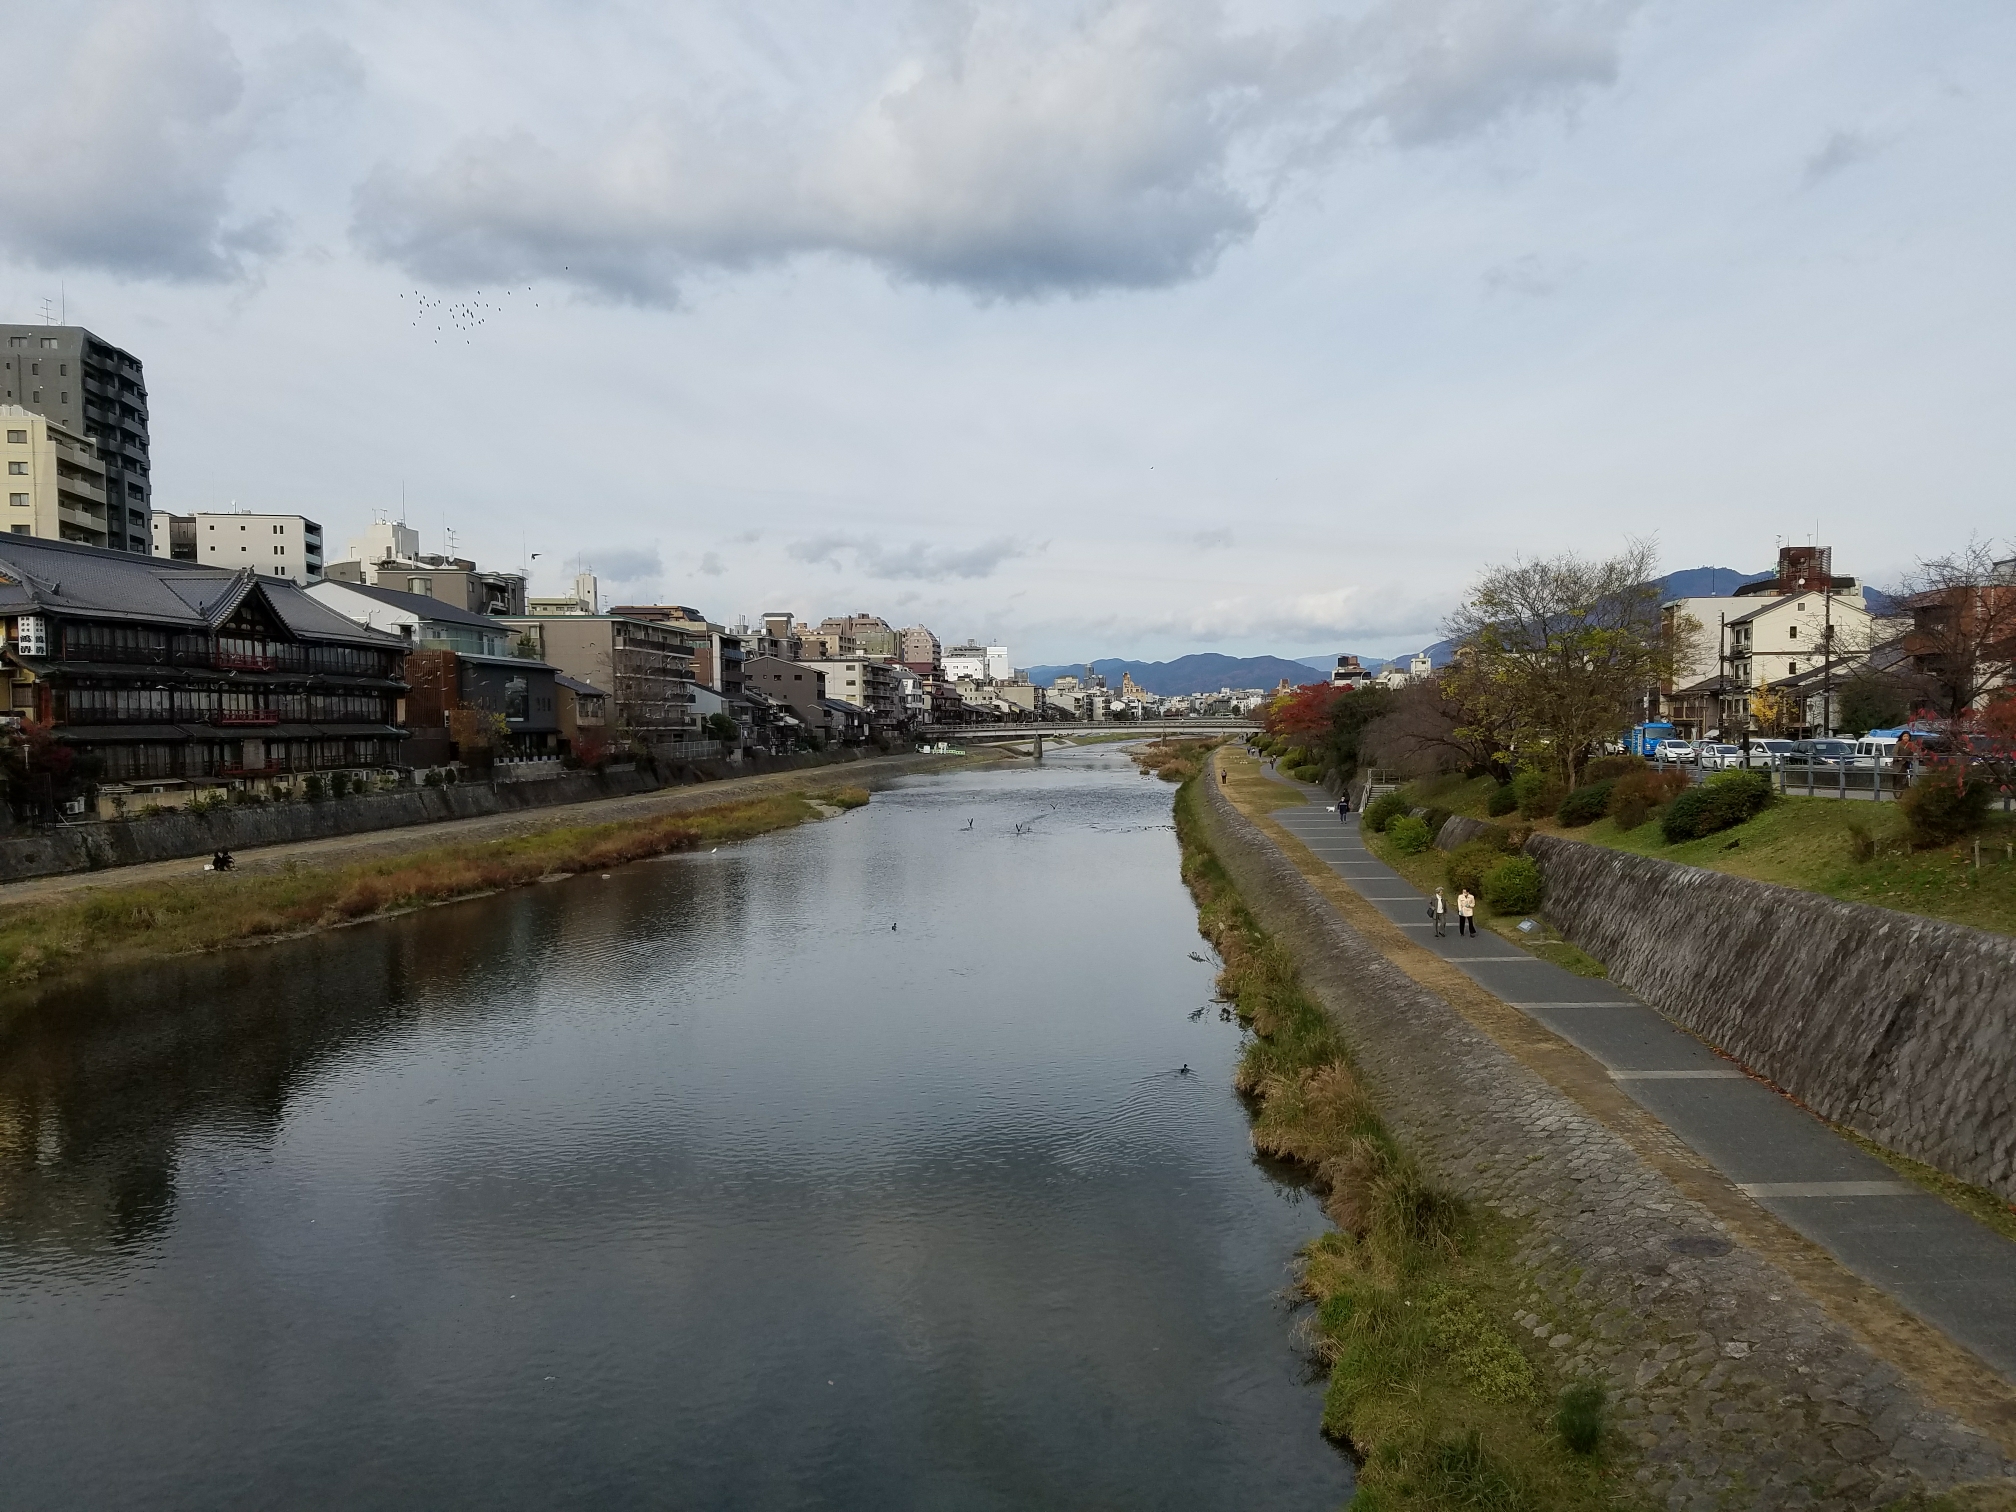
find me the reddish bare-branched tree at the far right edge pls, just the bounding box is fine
[1895,536,2016,718]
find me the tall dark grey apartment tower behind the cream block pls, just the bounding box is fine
[0,325,153,554]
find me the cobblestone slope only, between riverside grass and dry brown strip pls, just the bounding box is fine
[1206,762,2016,1512]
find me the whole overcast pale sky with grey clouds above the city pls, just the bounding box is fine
[0,0,2016,663]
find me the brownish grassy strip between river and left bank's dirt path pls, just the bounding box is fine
[0,788,869,988]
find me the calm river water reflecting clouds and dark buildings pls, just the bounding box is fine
[0,748,1351,1512]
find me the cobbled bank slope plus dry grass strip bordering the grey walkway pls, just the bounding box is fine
[1208,752,2016,1510]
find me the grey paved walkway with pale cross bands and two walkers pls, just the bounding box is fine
[1268,768,2016,1381]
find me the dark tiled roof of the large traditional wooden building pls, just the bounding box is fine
[0,536,403,645]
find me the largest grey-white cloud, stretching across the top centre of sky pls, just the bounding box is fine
[353,0,1629,302]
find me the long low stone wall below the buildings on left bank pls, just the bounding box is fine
[0,756,874,881]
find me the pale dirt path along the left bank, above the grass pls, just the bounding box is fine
[0,754,967,909]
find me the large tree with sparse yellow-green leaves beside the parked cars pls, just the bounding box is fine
[1447,540,1699,786]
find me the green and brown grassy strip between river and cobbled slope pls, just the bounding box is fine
[1175,780,1629,1512]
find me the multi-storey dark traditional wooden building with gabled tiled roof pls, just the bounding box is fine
[0,536,407,784]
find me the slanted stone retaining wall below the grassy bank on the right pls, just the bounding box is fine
[1526,835,2016,1200]
